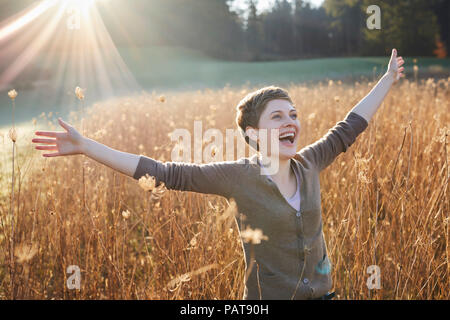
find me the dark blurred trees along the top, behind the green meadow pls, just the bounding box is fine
[0,0,450,61]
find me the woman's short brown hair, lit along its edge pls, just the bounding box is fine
[236,86,293,150]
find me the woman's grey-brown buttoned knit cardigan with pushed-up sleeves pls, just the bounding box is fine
[133,112,368,299]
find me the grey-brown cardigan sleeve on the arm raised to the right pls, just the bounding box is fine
[299,112,369,171]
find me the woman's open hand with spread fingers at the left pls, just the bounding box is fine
[32,118,85,157]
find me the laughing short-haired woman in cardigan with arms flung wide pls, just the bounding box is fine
[32,49,404,299]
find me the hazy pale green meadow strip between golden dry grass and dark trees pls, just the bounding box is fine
[0,47,450,131]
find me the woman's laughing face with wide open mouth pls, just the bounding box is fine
[248,99,300,160]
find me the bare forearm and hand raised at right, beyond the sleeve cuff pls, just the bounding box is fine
[351,49,405,122]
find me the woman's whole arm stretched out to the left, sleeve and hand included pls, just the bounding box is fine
[32,118,242,198]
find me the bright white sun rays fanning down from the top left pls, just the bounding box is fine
[0,0,141,105]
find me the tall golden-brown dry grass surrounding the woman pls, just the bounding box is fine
[0,78,450,299]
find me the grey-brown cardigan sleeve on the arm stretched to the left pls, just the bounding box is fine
[133,155,242,198]
